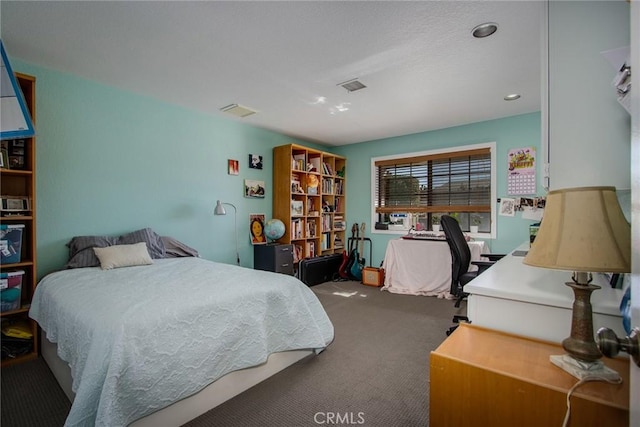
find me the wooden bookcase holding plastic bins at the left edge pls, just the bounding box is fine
[0,73,38,366]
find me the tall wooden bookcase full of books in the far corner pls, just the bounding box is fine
[273,144,346,263]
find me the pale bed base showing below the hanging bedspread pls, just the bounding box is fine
[41,334,316,427]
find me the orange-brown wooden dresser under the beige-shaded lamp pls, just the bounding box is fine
[429,326,629,427]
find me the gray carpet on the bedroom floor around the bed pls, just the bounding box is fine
[1,282,464,427]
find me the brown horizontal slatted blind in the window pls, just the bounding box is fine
[375,148,491,213]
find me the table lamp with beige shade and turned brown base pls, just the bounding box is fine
[523,187,631,380]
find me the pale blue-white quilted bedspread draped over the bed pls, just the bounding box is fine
[29,258,334,427]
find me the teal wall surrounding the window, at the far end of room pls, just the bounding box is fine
[335,113,545,266]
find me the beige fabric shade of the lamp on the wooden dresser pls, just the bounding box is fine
[523,187,631,273]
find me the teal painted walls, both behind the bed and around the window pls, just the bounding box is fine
[11,59,542,277]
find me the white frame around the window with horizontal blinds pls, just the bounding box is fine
[370,141,498,239]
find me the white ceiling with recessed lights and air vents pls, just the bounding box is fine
[0,0,544,145]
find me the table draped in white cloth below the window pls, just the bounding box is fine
[382,239,485,298]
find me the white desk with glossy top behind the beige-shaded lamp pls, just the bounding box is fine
[464,244,626,342]
